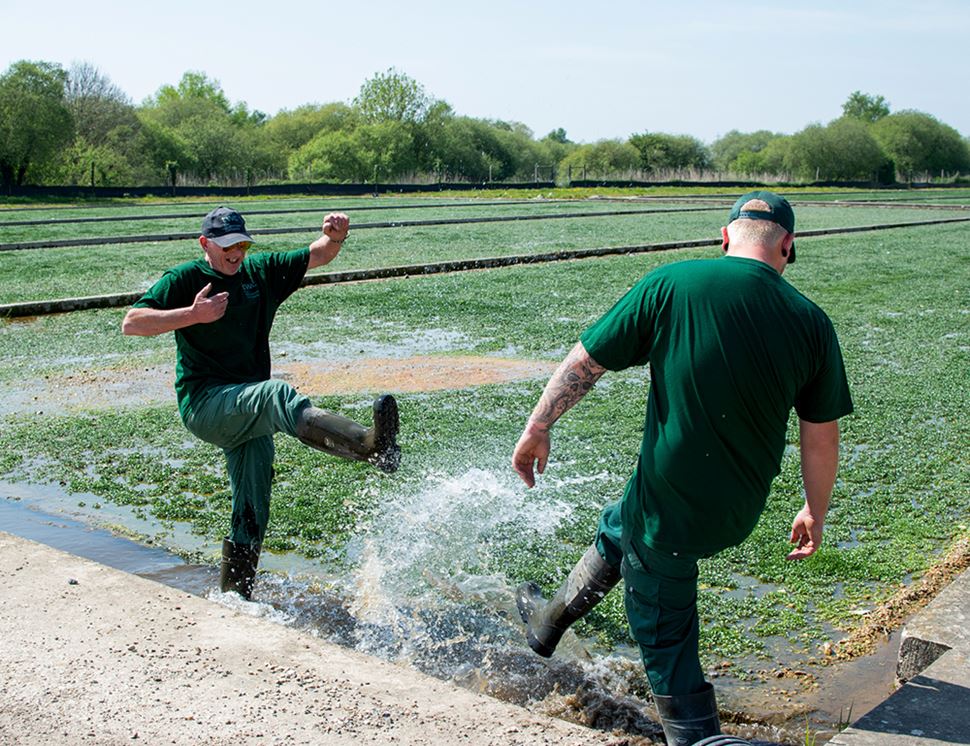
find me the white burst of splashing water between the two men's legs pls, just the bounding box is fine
[347,468,570,660]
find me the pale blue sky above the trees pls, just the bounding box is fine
[0,0,970,142]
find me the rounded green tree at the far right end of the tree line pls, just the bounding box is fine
[872,110,970,181]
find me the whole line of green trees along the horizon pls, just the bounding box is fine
[0,60,970,189]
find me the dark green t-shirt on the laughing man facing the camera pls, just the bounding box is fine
[135,249,310,416]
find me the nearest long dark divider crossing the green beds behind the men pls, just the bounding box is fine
[0,217,970,318]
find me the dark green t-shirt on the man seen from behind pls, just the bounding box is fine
[581,257,852,556]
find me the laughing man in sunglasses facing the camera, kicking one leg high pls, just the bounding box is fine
[122,207,401,599]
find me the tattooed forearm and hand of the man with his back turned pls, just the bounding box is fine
[512,342,606,487]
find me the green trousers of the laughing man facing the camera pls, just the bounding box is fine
[183,380,310,545]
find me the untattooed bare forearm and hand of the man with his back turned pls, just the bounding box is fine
[788,420,839,560]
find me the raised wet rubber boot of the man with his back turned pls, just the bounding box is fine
[515,545,620,658]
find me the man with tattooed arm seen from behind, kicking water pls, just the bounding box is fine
[512,191,852,744]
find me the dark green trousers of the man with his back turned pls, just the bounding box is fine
[596,501,705,696]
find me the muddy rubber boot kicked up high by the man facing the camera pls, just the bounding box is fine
[296,394,401,474]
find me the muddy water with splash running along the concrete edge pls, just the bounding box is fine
[0,472,897,745]
